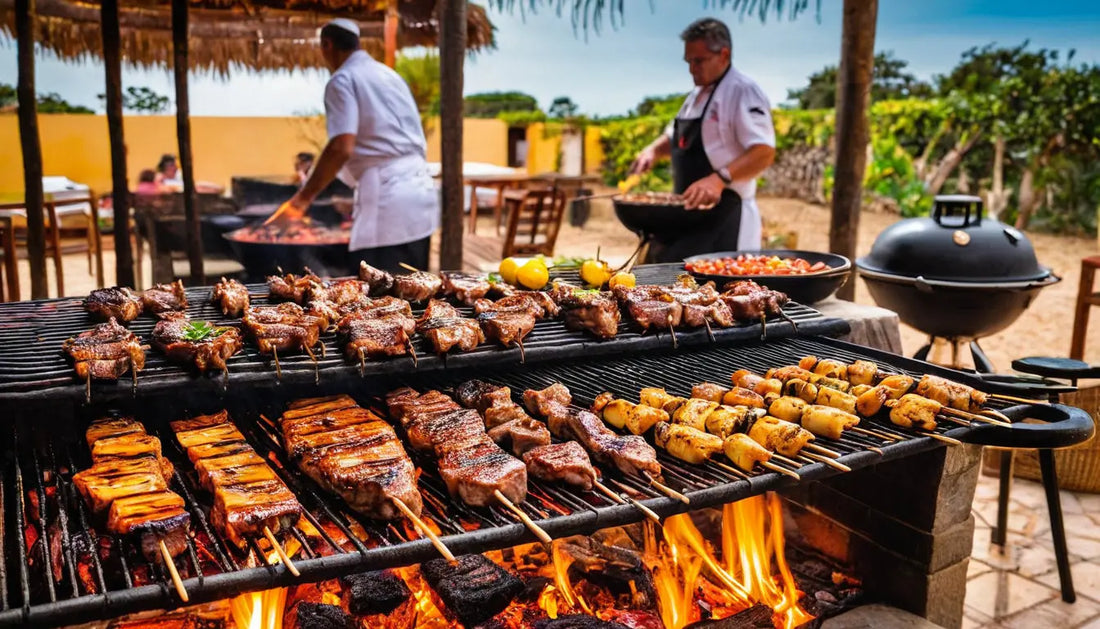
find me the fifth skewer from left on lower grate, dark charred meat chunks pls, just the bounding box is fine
[455,380,660,521]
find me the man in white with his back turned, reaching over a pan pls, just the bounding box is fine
[268,18,440,272]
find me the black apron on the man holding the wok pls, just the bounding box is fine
[646,69,741,263]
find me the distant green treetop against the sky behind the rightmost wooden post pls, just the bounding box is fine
[787,51,934,109]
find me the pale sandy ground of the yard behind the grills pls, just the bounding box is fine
[20,199,1100,372]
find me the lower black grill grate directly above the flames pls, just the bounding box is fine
[0,339,1012,626]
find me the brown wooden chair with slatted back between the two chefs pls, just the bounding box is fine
[501,188,565,257]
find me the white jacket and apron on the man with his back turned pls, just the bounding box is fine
[325,51,439,251]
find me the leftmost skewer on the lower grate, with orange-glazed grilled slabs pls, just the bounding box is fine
[73,418,190,603]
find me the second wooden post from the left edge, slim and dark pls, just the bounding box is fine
[100,0,138,287]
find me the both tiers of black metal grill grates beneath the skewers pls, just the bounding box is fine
[0,266,1092,626]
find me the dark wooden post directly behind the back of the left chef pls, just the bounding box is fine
[439,0,466,271]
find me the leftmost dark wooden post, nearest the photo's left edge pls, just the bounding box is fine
[13,0,50,299]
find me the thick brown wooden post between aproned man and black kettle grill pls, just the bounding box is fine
[828,0,879,301]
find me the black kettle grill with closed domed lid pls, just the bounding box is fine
[856,195,1060,372]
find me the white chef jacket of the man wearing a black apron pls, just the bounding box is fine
[666,66,776,251]
